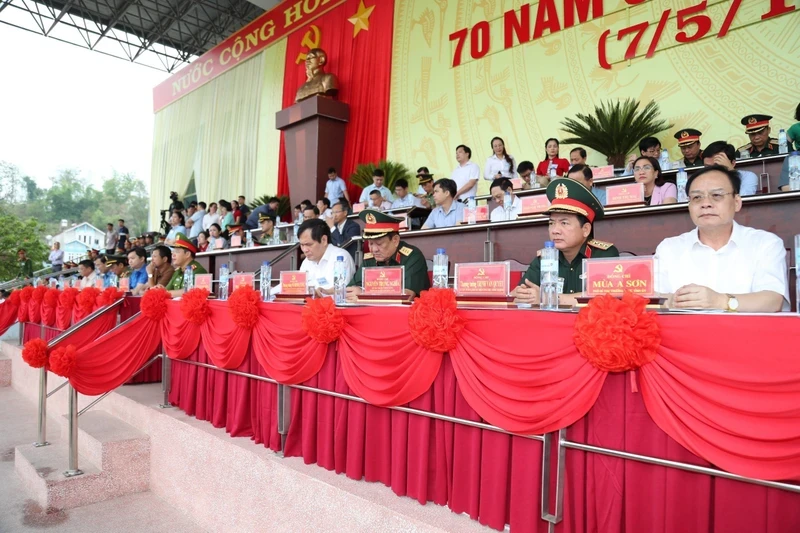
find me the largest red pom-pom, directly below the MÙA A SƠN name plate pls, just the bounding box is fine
[572,293,661,372]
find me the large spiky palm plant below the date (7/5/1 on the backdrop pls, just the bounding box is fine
[561,98,672,168]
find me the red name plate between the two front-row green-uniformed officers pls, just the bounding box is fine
[454,261,513,305]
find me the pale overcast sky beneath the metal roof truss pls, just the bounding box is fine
[0,24,168,188]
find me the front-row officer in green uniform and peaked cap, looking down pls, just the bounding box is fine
[347,209,431,302]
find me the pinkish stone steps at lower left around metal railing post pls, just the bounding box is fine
[15,411,150,509]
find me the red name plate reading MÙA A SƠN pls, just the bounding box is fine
[583,257,656,296]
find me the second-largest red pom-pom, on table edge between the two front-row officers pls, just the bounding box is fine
[408,289,464,352]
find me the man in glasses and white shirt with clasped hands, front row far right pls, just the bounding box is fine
[656,165,789,313]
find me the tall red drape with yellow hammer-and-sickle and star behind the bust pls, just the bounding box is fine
[278,0,394,202]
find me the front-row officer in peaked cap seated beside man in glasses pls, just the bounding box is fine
[512,179,619,305]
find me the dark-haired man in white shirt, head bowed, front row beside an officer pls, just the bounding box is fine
[273,218,356,297]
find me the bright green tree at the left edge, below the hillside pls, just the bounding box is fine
[0,206,48,281]
